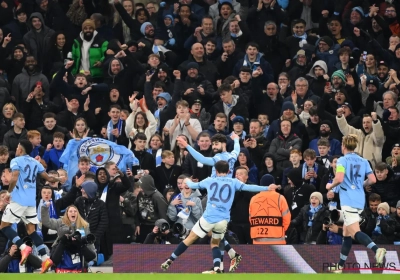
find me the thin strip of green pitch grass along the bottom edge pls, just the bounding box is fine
[0,273,400,280]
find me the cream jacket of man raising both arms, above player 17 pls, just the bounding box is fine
[336,117,385,168]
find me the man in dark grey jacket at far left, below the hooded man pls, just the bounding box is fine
[11,55,50,110]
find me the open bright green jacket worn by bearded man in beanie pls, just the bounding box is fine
[72,31,108,78]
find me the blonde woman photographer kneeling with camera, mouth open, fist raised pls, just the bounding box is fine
[41,203,96,273]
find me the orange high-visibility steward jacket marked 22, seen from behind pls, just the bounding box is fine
[249,191,291,244]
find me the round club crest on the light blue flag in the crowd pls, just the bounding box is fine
[78,138,122,167]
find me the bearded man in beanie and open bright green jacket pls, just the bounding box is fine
[72,19,108,80]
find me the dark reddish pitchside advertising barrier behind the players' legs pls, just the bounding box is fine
[113,244,400,274]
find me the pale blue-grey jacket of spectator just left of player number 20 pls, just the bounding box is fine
[167,191,203,229]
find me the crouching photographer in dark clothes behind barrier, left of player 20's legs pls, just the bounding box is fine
[143,219,181,244]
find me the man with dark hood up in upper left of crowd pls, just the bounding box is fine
[24,13,54,70]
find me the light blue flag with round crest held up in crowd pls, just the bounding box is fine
[60,137,139,184]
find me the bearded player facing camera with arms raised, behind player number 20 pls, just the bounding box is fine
[176,133,240,177]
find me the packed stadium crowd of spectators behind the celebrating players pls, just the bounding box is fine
[0,0,400,272]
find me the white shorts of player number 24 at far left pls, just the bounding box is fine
[1,202,39,225]
